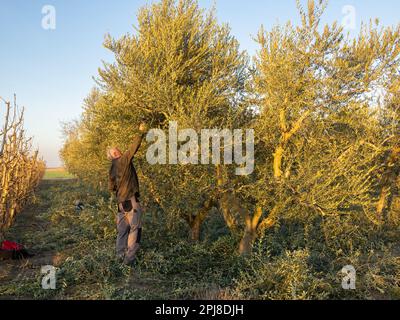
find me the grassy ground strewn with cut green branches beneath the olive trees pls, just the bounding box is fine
[0,180,400,300]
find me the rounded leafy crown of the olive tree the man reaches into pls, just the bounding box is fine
[61,0,249,238]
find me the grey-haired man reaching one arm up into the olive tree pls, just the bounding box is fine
[107,124,147,266]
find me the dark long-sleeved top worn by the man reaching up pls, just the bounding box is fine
[109,135,143,203]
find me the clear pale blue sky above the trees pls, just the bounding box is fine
[0,0,400,167]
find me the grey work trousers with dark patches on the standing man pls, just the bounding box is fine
[117,197,142,264]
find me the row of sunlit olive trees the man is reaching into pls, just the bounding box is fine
[61,0,400,253]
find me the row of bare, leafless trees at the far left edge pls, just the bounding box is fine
[0,98,45,235]
